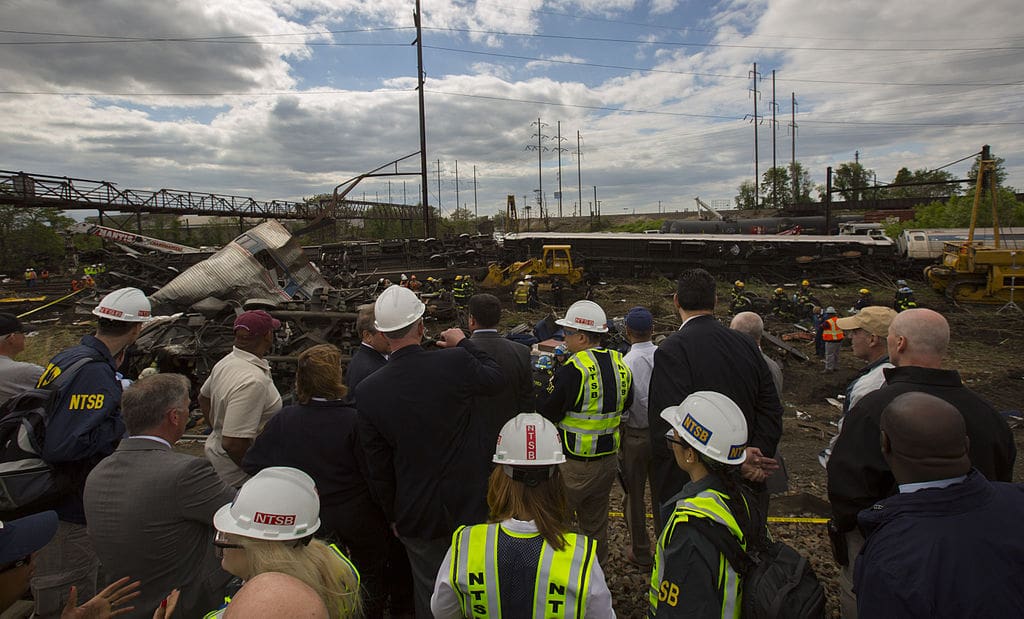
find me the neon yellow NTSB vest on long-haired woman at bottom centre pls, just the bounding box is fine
[450,524,596,619]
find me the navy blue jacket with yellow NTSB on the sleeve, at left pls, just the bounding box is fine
[39,335,125,525]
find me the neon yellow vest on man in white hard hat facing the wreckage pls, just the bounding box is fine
[558,348,633,458]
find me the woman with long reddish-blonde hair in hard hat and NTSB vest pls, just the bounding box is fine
[430,413,615,619]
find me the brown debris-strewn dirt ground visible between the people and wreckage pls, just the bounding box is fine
[8,279,1024,617]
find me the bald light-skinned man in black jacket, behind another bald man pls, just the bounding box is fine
[827,308,1017,618]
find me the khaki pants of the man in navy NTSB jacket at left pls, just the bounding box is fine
[31,521,99,619]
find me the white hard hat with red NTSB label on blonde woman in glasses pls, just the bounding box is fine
[213,466,319,541]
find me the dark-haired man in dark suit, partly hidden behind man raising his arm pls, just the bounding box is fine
[469,293,534,445]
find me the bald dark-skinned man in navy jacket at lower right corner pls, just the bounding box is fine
[854,391,1024,619]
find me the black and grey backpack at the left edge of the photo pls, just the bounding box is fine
[0,357,95,520]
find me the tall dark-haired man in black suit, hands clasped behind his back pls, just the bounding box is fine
[647,269,782,515]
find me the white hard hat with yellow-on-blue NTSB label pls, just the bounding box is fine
[662,391,746,464]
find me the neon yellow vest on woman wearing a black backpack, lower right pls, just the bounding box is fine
[647,489,746,619]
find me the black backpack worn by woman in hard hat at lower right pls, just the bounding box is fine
[688,519,825,619]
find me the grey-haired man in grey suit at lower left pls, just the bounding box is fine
[85,374,234,619]
